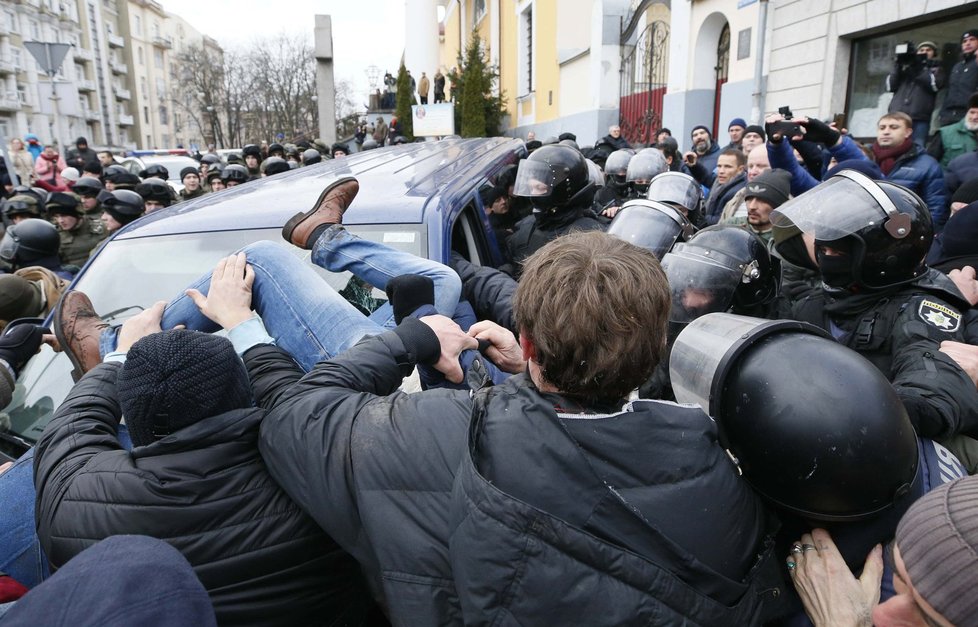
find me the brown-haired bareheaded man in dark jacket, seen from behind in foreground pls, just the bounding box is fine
[193,228,777,625]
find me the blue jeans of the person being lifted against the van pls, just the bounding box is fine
[101,229,462,372]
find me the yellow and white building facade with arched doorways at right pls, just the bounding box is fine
[430,0,978,146]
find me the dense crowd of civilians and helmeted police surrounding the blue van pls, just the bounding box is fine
[0,31,978,627]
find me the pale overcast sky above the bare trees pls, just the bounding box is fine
[159,0,404,104]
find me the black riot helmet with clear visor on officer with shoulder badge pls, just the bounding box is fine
[771,170,934,290]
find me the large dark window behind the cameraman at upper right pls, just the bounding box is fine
[846,16,961,138]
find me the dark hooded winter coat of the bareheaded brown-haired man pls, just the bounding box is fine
[255,320,776,625]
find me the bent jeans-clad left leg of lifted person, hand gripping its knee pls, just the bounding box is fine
[161,242,383,371]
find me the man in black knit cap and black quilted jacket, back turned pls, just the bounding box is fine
[34,300,370,625]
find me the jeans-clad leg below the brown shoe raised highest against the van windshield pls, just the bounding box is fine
[312,225,462,327]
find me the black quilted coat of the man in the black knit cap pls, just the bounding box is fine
[34,364,370,625]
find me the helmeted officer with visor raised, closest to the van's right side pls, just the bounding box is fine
[506,145,604,272]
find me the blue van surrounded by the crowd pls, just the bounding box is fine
[0,138,526,463]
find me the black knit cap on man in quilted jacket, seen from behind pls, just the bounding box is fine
[116,329,253,446]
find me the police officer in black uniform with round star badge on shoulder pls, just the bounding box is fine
[771,170,978,439]
